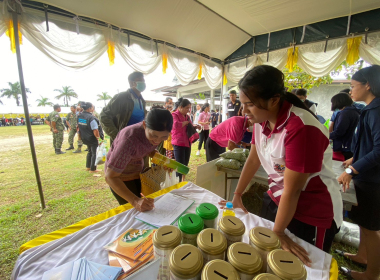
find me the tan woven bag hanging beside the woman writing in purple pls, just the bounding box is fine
[140,166,166,195]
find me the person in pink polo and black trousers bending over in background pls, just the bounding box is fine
[206,117,250,162]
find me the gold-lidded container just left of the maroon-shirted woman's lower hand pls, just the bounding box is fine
[249,227,281,272]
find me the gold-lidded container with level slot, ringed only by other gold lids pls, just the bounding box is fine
[227,242,263,280]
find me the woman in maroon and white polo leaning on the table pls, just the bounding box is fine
[221,65,343,266]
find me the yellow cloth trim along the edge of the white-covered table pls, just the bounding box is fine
[20,182,338,280]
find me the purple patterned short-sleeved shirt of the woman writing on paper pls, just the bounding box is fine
[105,122,157,181]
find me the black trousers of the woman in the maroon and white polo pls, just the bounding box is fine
[260,193,339,253]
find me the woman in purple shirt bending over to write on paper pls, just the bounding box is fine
[105,107,173,212]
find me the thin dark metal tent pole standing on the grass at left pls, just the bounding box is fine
[12,12,46,209]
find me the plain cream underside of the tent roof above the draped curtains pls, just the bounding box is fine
[30,0,380,60]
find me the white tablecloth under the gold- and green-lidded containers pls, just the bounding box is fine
[11,183,331,280]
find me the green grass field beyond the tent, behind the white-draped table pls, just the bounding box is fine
[0,125,358,279]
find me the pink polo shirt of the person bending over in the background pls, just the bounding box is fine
[209,117,248,148]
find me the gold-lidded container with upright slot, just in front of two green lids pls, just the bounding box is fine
[197,228,227,264]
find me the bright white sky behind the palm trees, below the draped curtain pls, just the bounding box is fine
[0,34,175,108]
